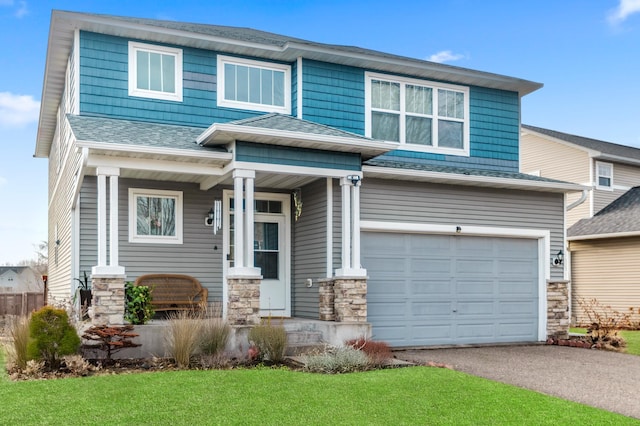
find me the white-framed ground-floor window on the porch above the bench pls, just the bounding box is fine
[129,188,182,244]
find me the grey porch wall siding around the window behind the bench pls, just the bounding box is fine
[80,177,223,301]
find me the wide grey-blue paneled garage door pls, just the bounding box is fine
[362,232,538,346]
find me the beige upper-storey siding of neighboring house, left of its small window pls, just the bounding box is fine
[520,129,591,227]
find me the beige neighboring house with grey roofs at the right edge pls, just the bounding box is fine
[520,125,640,324]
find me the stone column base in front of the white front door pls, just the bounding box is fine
[227,277,262,325]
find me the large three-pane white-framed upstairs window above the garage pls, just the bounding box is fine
[365,73,469,155]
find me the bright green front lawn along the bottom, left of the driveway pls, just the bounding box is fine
[0,351,638,425]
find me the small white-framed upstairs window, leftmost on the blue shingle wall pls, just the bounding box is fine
[129,41,182,102]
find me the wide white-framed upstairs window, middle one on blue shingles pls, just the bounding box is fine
[217,55,291,114]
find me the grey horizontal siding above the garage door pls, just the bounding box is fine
[360,179,564,279]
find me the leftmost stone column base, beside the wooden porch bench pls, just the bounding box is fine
[91,274,125,325]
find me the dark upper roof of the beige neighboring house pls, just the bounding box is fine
[522,124,640,164]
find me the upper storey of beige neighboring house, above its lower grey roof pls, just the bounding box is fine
[520,124,640,228]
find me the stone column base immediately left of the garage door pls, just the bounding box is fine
[334,277,367,322]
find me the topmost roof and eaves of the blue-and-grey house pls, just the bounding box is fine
[35,10,542,157]
